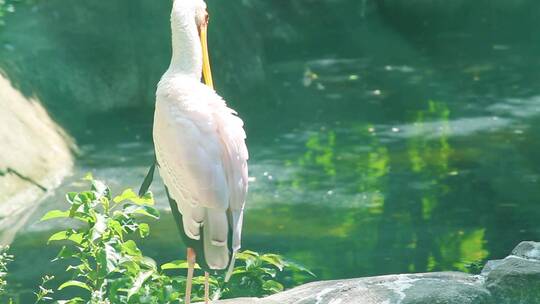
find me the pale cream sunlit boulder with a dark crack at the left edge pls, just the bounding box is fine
[0,74,73,245]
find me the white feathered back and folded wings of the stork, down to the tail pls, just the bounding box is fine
[154,81,248,269]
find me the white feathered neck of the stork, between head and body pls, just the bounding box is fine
[168,23,203,80]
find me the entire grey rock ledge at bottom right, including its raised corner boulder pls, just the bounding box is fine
[209,242,540,304]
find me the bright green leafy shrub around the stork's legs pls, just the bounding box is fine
[32,176,310,304]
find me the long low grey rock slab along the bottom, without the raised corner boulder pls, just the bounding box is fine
[206,272,491,304]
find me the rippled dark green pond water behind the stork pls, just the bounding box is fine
[0,0,540,300]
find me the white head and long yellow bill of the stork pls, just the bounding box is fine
[171,0,214,88]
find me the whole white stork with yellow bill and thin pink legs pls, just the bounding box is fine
[153,0,248,303]
